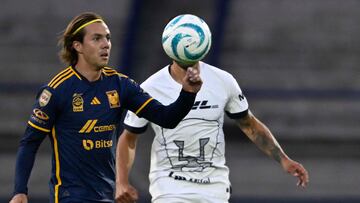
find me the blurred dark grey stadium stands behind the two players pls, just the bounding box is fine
[0,0,360,203]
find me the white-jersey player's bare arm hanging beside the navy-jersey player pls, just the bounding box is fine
[115,130,138,203]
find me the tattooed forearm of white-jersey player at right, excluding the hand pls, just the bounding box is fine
[240,114,288,163]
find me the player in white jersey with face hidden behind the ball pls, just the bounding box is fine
[115,61,309,203]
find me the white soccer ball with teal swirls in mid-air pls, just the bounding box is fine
[162,14,211,66]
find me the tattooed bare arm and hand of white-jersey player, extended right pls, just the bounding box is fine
[236,111,309,187]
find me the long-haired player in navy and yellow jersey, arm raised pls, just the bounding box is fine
[10,12,202,203]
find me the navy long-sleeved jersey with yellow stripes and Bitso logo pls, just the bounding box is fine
[15,67,195,202]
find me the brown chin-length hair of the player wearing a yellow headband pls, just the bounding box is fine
[58,12,103,65]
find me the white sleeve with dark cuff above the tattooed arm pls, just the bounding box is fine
[225,75,249,119]
